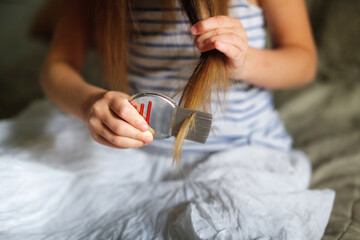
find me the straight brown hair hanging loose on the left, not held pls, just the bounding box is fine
[94,0,131,92]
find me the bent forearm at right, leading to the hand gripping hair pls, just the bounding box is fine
[241,46,316,89]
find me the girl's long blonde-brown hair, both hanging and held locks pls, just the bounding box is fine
[95,0,229,162]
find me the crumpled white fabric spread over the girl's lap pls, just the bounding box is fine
[0,101,334,240]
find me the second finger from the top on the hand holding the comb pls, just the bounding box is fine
[102,110,152,143]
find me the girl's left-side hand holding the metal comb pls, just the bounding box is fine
[88,91,153,148]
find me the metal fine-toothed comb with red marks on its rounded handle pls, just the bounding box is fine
[130,92,212,143]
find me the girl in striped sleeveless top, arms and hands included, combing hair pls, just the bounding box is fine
[41,0,316,152]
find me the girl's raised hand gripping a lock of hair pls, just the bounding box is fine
[191,16,248,78]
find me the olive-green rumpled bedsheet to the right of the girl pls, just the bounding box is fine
[277,81,360,240]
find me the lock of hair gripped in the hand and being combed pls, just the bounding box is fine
[173,0,229,162]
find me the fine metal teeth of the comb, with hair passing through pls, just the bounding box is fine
[171,107,212,143]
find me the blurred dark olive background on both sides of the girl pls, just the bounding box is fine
[0,0,360,239]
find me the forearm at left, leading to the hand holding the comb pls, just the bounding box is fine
[41,61,105,122]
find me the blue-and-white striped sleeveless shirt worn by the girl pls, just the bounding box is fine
[128,0,292,153]
